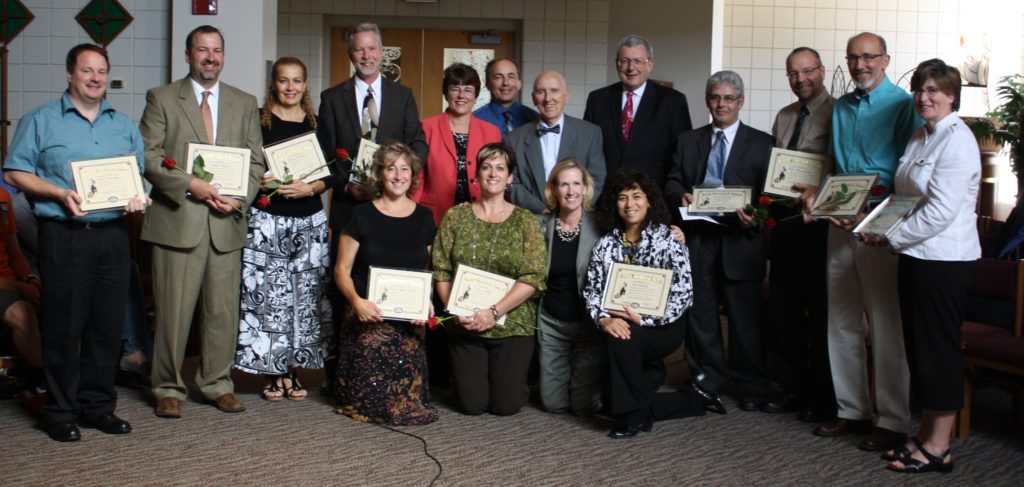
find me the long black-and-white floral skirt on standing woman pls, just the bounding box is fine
[234,208,334,375]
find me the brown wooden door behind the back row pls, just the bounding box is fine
[331,27,515,119]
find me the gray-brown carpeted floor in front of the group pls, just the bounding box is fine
[0,356,1024,487]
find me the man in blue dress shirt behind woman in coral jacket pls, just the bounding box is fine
[473,57,538,139]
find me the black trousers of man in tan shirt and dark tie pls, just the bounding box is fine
[765,218,836,415]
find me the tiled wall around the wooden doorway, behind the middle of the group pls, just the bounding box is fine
[278,0,609,117]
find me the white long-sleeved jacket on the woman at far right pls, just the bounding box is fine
[889,112,981,261]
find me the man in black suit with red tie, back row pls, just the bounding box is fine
[583,35,693,186]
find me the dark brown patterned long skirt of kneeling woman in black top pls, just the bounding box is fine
[335,319,437,426]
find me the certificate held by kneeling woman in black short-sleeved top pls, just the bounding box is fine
[367,267,433,320]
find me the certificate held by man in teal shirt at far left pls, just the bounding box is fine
[70,154,145,212]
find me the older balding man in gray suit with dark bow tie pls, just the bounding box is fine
[507,71,606,213]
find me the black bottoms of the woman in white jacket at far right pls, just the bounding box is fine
[897,254,975,411]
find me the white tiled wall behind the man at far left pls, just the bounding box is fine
[7,0,169,127]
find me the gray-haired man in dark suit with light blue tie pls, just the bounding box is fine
[665,71,772,411]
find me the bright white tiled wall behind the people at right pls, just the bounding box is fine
[722,0,1024,131]
